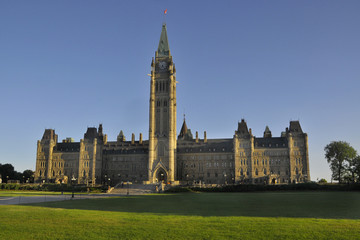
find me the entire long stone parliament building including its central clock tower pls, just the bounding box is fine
[35,24,310,185]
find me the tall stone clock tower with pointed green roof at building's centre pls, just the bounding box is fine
[148,23,176,183]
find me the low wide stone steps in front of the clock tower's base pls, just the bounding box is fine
[109,183,156,195]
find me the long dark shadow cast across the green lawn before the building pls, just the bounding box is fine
[27,192,360,219]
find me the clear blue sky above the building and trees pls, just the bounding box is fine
[0,0,360,180]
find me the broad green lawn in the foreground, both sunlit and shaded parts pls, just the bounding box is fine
[0,192,360,239]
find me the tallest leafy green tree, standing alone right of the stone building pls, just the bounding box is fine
[324,141,357,183]
